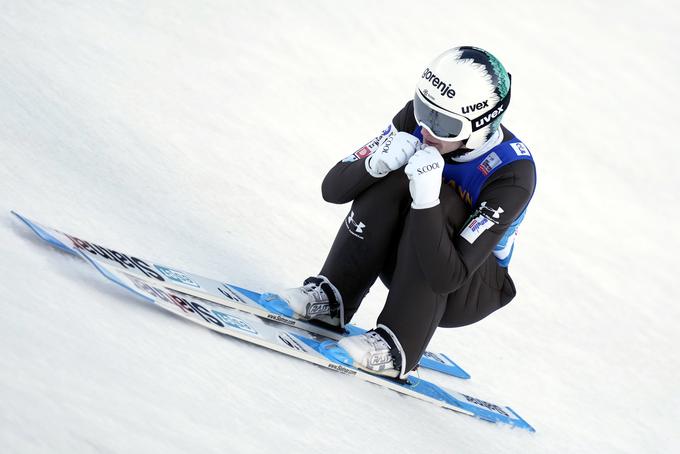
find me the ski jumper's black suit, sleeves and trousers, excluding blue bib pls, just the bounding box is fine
[320,102,536,371]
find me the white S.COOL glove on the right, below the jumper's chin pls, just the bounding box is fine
[404,147,444,210]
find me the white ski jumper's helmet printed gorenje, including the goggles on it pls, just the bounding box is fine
[413,46,510,150]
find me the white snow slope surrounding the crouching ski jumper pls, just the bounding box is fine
[0,0,680,453]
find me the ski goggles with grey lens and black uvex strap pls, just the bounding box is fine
[413,77,510,142]
